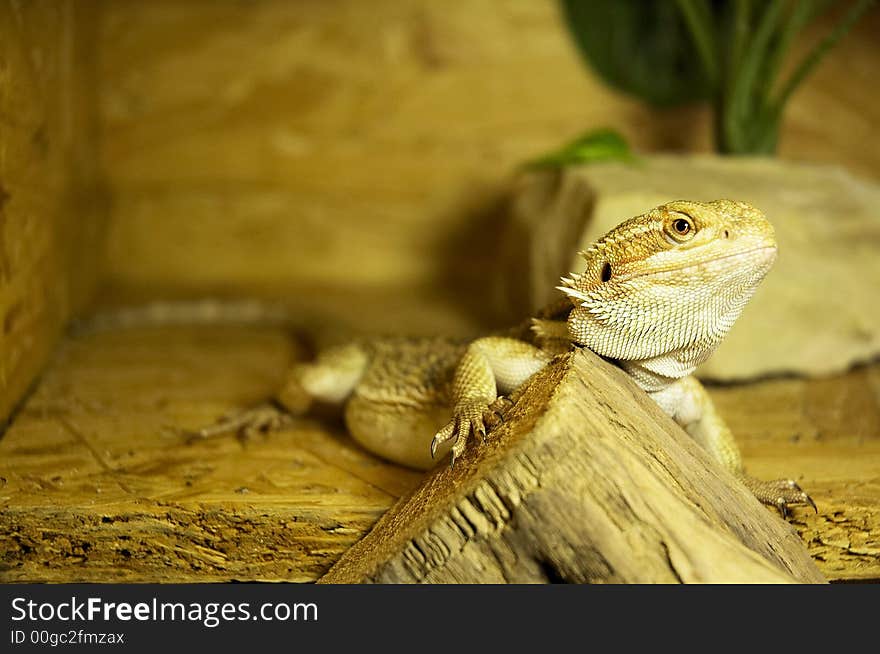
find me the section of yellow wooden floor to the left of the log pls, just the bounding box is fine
[0,327,420,582]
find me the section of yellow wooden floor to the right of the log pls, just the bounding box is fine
[709,363,880,581]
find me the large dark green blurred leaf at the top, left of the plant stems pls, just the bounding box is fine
[560,0,712,107]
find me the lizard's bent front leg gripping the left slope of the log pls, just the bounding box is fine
[431,336,550,465]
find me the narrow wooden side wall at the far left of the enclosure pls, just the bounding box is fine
[0,0,101,426]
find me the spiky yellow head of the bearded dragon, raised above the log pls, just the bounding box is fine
[558,200,776,366]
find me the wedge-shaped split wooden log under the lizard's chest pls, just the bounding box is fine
[321,350,823,583]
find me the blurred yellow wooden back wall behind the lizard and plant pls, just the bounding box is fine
[99,0,880,308]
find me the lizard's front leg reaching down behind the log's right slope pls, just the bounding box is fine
[649,376,816,517]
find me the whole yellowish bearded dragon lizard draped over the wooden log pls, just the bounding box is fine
[191,200,816,516]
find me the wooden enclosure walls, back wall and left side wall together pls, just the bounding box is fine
[0,0,880,362]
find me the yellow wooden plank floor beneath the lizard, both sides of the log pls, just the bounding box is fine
[0,327,880,582]
